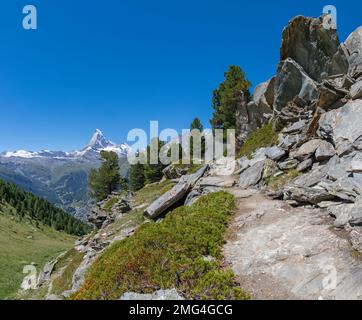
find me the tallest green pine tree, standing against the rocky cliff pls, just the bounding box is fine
[210,65,251,130]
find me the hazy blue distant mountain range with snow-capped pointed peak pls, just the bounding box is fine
[0,129,130,220]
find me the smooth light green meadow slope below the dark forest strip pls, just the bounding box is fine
[0,206,76,299]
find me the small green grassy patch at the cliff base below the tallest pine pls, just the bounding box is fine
[239,123,278,158]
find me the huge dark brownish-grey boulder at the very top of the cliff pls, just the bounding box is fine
[279,16,350,82]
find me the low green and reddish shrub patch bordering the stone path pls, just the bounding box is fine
[72,192,249,300]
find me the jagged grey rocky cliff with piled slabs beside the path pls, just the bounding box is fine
[238,13,362,255]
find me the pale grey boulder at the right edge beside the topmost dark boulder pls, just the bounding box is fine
[344,27,362,76]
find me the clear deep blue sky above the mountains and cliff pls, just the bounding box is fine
[0,0,362,151]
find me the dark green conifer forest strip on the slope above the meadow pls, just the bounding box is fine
[0,180,90,236]
